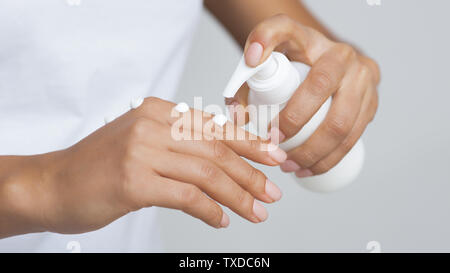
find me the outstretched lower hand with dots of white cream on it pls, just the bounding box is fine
[15,98,286,233]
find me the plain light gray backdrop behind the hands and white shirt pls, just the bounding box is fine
[160,0,450,252]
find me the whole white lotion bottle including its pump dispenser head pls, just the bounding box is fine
[223,52,364,192]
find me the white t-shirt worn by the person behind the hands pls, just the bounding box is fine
[0,0,202,252]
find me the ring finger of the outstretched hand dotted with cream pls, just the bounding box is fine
[149,149,267,223]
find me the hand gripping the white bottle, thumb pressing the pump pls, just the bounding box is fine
[226,15,380,177]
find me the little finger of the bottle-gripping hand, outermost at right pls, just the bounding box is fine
[306,88,378,175]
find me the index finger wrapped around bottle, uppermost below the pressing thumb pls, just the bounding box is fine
[276,43,356,139]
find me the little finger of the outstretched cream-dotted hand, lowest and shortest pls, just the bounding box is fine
[136,175,230,228]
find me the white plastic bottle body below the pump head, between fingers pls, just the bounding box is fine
[248,62,365,192]
